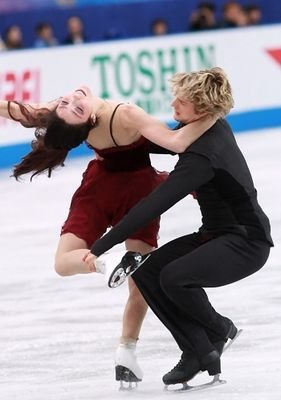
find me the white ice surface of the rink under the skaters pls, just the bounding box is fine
[0,129,281,400]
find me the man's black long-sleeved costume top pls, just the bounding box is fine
[91,120,273,256]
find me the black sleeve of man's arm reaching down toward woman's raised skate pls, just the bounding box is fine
[91,152,214,256]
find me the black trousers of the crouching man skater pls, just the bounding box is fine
[132,233,270,360]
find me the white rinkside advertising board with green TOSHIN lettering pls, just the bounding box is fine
[0,25,281,166]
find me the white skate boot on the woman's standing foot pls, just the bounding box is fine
[115,343,143,390]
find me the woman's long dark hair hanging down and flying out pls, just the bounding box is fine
[12,110,93,180]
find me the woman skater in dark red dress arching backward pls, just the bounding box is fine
[0,86,215,381]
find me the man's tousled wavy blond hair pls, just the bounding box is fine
[170,67,234,117]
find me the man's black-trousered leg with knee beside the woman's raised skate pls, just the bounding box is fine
[133,234,241,379]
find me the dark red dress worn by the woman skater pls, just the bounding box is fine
[61,137,167,247]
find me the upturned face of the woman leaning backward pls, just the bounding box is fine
[56,86,93,125]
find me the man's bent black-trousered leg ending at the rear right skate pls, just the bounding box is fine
[160,234,269,342]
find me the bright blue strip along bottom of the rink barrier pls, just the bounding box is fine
[0,108,281,168]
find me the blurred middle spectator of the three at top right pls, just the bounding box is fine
[220,0,247,28]
